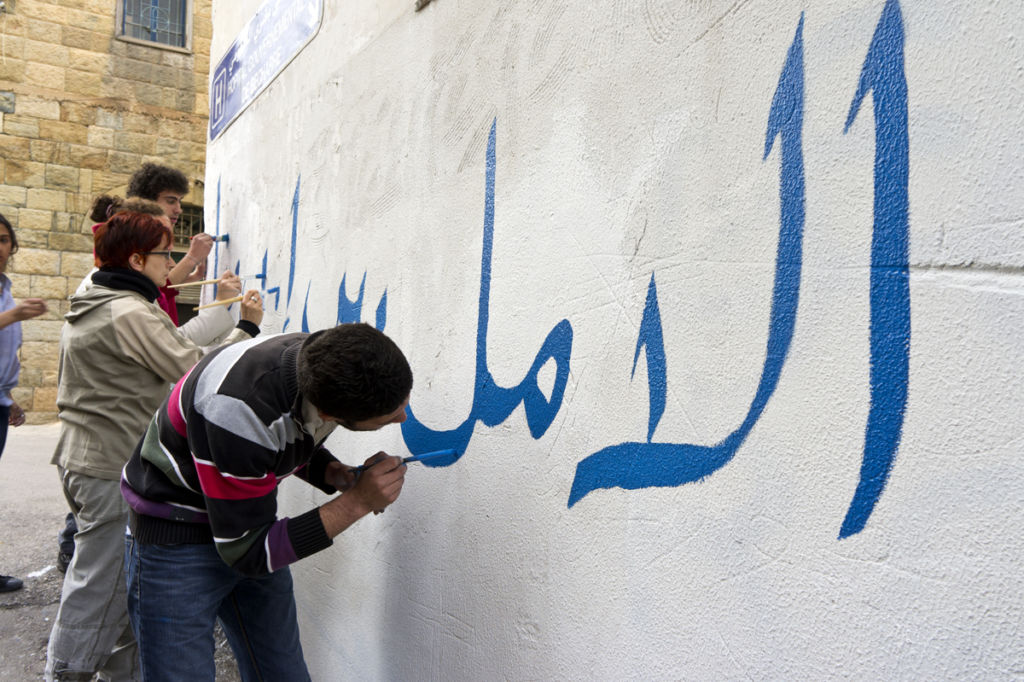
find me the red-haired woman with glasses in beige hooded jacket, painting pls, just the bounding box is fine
[45,211,263,680]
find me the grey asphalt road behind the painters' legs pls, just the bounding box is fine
[0,424,240,682]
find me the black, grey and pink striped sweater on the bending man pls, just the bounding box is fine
[121,334,337,576]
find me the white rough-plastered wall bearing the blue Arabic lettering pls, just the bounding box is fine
[207,0,1024,680]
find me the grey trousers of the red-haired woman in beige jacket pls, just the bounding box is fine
[44,467,139,682]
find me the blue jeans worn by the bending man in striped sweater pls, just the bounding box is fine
[125,537,309,682]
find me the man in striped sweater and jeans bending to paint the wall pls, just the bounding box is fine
[121,324,413,682]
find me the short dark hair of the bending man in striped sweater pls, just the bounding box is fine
[299,323,413,422]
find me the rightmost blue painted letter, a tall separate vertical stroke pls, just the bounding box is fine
[839,0,910,539]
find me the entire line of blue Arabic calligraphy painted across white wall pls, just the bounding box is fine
[215,0,910,539]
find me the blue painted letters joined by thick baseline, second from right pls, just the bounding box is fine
[568,16,805,507]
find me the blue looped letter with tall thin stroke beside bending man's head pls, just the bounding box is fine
[401,120,572,466]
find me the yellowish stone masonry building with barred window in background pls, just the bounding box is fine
[0,0,212,423]
